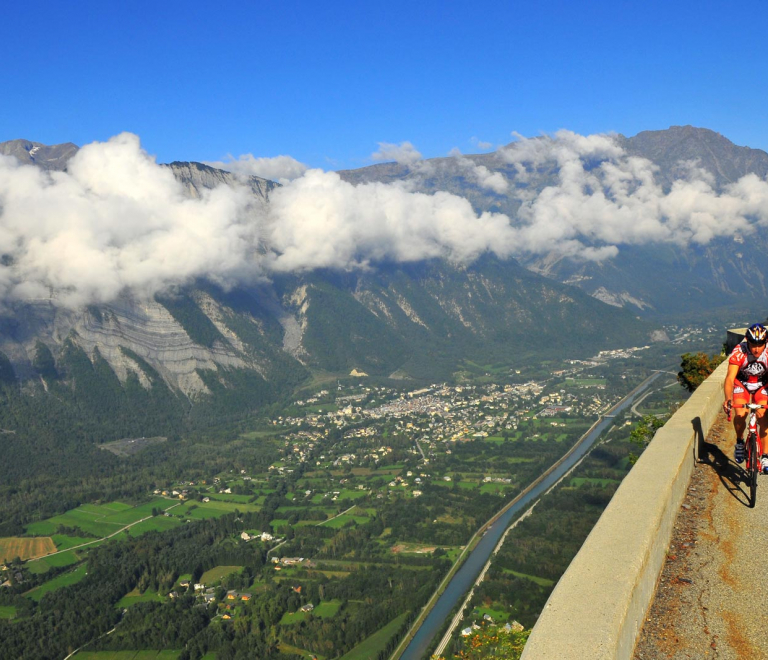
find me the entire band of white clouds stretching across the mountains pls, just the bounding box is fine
[0,131,768,308]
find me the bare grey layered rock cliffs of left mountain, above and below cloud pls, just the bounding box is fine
[0,145,284,397]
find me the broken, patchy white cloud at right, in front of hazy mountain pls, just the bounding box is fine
[500,131,768,258]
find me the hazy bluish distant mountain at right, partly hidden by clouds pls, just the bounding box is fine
[340,126,768,318]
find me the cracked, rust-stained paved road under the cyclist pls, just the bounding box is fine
[635,416,768,660]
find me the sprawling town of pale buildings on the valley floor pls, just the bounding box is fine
[258,354,647,482]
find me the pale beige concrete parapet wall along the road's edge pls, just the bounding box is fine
[522,360,728,660]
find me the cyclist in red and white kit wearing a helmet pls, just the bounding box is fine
[723,323,768,473]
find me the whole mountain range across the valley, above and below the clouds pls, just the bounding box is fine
[0,126,768,433]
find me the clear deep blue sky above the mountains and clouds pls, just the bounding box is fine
[0,0,768,169]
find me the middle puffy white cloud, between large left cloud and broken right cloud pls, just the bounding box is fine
[267,170,514,272]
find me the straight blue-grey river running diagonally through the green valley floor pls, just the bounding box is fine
[400,373,661,660]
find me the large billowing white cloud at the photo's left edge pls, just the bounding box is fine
[0,133,260,307]
